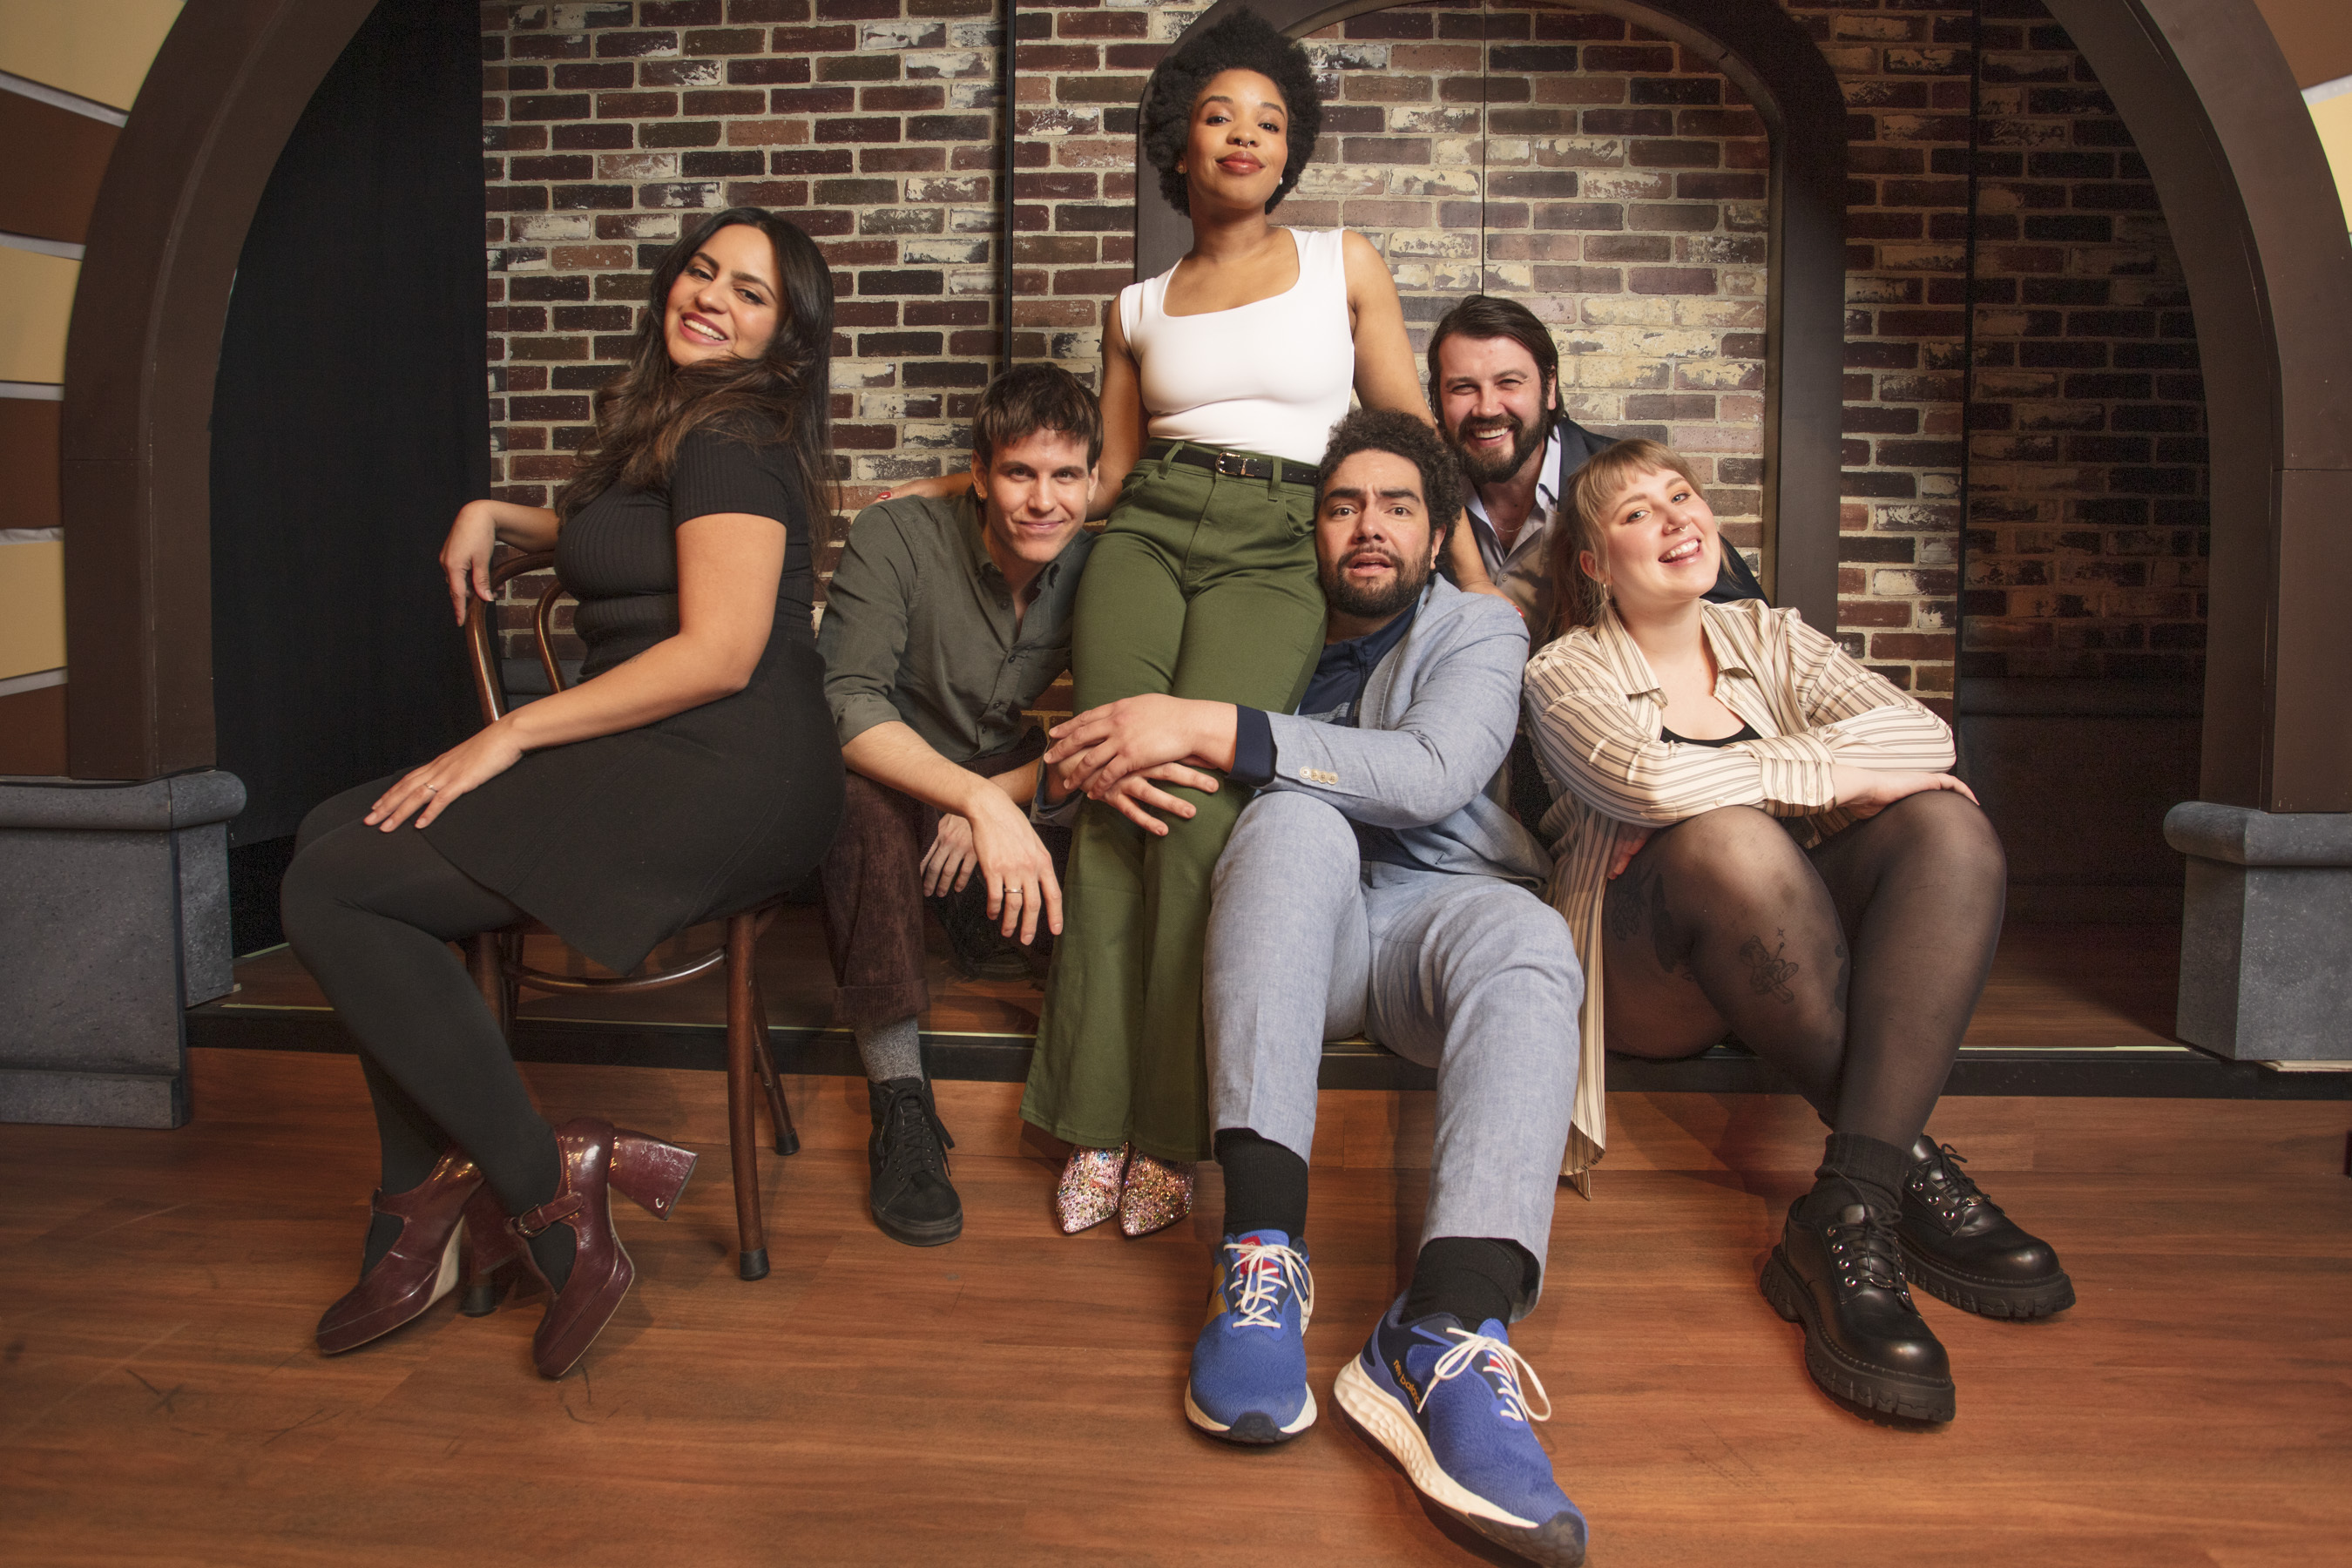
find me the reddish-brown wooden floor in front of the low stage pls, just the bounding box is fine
[0,1051,2352,1568]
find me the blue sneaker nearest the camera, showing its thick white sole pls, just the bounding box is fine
[1336,1295,1585,1568]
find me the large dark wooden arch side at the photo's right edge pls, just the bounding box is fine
[2044,0,2352,811]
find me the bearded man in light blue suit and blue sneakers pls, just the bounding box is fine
[1047,411,1585,1564]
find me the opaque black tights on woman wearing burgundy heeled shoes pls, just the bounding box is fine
[282,781,571,1286]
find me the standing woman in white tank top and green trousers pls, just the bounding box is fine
[1021,10,1428,1234]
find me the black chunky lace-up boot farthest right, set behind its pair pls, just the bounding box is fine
[1896,1133,2074,1319]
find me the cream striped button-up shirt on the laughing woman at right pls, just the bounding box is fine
[1522,599,1952,1197]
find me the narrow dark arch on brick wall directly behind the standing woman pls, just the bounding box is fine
[1136,0,1847,628]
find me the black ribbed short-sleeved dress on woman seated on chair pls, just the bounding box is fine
[423,430,842,971]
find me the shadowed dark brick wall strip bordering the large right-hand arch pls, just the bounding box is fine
[1962,0,2208,679]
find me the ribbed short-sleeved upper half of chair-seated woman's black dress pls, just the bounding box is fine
[555,430,816,679]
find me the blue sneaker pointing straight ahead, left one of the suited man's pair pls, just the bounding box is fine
[1183,1229,1315,1443]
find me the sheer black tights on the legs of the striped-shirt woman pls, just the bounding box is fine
[1602,790,2009,1147]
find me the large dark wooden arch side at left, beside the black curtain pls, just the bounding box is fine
[59,0,374,778]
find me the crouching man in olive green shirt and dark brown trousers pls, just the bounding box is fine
[816,364,1103,1246]
